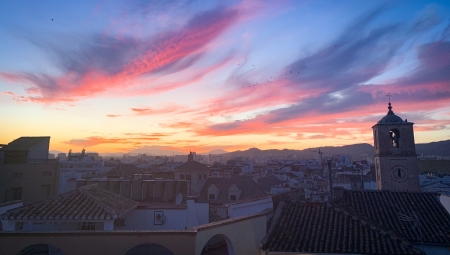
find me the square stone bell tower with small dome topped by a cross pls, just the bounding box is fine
[372,97,420,191]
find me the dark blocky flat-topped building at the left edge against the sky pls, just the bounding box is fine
[0,137,59,203]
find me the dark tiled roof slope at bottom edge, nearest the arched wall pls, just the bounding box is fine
[263,203,424,254]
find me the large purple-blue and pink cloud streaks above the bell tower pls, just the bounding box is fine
[196,6,450,139]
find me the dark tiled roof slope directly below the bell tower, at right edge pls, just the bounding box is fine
[336,190,450,245]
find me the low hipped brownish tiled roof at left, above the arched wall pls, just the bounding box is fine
[1,184,139,221]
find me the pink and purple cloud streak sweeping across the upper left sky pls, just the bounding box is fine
[0,4,243,103]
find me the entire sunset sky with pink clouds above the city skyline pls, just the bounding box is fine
[0,0,450,153]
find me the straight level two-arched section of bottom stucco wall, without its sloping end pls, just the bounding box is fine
[0,231,195,255]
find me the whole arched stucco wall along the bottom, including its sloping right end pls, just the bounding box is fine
[0,211,267,255]
